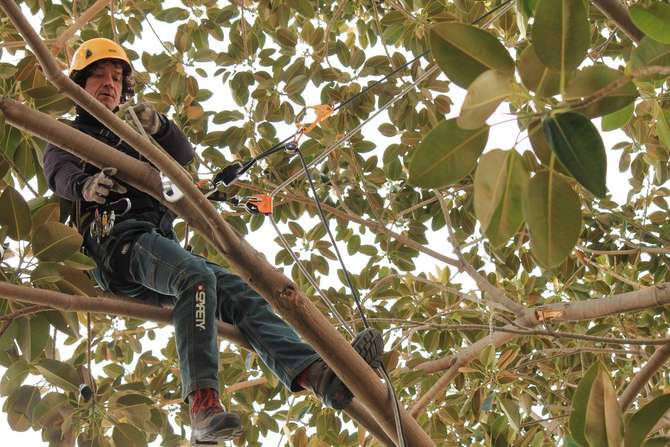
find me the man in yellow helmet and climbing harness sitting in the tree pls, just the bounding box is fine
[44,38,381,444]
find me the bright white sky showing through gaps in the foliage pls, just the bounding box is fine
[0,0,628,446]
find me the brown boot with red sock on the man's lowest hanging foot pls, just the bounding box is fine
[188,388,242,446]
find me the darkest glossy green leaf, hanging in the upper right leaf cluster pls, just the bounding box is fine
[543,112,607,197]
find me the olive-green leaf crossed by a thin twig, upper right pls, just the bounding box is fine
[564,64,638,118]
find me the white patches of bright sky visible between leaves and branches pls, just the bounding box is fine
[0,0,628,446]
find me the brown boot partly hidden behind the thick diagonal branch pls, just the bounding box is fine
[298,328,384,410]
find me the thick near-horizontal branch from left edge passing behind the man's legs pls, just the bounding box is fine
[0,281,251,350]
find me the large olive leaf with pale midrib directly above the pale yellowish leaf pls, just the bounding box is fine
[430,23,514,88]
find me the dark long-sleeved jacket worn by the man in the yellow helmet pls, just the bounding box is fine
[44,110,195,296]
